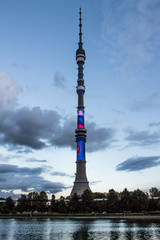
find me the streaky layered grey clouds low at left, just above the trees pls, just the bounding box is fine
[0,164,67,199]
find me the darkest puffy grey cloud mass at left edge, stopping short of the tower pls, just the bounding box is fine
[0,107,60,149]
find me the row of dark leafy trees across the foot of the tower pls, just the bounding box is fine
[0,188,160,213]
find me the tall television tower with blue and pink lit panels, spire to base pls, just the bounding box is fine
[71,8,90,196]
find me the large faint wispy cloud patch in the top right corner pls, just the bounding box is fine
[102,0,160,79]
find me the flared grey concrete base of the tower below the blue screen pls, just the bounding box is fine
[71,161,90,196]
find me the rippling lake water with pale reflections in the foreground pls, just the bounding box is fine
[0,219,160,240]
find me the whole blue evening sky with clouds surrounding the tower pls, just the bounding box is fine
[0,0,160,199]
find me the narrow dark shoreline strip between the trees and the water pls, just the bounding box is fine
[0,215,160,220]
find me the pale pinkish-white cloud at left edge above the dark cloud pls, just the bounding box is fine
[0,72,18,112]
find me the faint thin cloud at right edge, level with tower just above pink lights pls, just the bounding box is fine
[131,92,160,111]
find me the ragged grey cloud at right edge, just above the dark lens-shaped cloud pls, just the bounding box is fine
[125,129,160,146]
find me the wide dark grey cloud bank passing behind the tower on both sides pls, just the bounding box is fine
[0,107,115,153]
